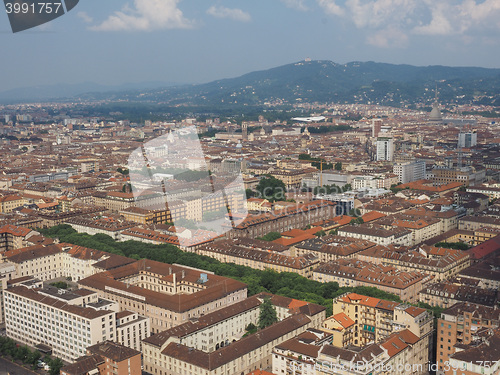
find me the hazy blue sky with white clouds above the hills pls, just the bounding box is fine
[0,0,500,91]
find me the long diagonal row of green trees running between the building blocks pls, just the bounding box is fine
[41,224,401,315]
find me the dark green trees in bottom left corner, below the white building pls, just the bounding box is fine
[0,336,64,375]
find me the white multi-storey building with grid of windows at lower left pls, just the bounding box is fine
[4,285,117,362]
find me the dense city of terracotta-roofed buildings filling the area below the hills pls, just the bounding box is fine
[0,83,500,375]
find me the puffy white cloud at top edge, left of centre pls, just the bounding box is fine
[91,0,194,31]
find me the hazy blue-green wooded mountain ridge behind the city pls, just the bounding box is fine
[0,60,500,106]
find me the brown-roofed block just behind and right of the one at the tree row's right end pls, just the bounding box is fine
[358,245,471,281]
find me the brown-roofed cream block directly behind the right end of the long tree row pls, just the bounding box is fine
[312,259,431,303]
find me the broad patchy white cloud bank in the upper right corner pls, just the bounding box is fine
[316,0,500,47]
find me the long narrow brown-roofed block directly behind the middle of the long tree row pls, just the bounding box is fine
[195,238,319,278]
